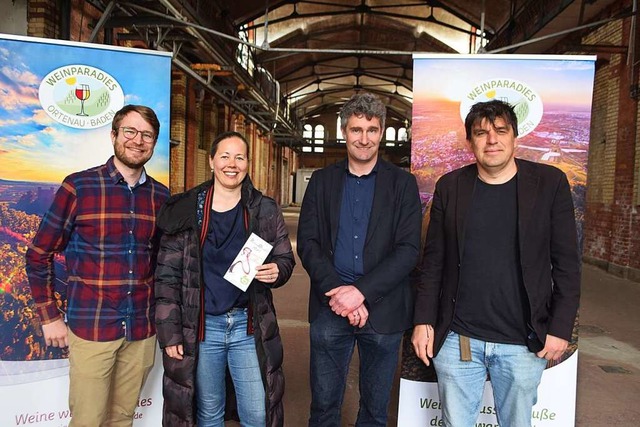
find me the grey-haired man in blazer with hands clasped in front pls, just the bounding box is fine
[298,93,422,427]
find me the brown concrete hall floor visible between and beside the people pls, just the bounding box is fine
[235,208,640,427]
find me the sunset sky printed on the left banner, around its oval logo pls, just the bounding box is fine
[0,37,171,184]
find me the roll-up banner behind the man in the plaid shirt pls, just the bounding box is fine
[0,34,171,427]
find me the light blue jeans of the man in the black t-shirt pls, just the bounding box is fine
[433,331,547,427]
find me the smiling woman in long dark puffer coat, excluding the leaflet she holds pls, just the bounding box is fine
[155,132,295,427]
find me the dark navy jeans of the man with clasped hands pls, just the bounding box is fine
[309,308,402,427]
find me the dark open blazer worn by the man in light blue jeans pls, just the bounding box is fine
[414,159,580,355]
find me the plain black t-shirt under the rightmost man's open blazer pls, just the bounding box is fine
[451,174,529,344]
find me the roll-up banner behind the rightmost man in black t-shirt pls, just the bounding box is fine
[398,55,596,427]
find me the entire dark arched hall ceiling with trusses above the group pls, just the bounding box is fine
[89,0,631,142]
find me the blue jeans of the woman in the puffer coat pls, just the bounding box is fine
[196,308,266,427]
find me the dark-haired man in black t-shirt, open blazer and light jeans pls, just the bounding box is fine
[412,101,580,427]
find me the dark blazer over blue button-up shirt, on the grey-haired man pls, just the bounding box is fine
[297,159,422,333]
